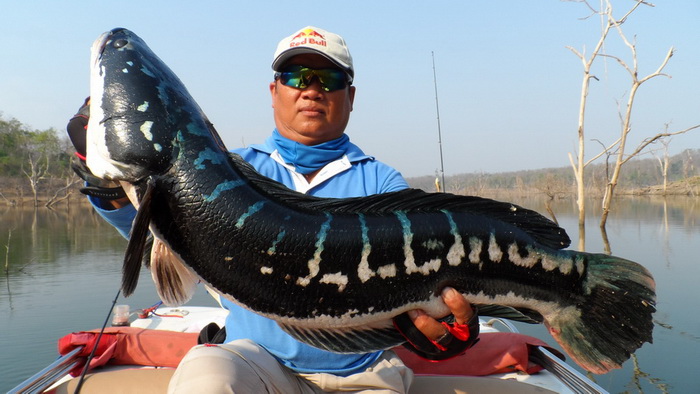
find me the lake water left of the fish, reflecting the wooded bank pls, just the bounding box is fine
[0,207,214,392]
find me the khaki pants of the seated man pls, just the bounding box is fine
[168,339,413,394]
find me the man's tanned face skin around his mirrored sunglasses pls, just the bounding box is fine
[270,54,355,145]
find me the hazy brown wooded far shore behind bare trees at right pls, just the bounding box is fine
[407,149,700,195]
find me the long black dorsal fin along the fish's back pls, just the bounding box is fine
[229,153,571,249]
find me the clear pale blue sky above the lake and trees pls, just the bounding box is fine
[0,0,700,177]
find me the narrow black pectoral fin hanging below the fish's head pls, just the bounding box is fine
[122,178,155,297]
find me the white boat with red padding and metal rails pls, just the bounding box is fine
[9,303,606,394]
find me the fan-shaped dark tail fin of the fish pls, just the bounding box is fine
[545,252,656,374]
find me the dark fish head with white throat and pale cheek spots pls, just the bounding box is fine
[87,28,201,183]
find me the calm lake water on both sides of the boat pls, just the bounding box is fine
[0,197,700,393]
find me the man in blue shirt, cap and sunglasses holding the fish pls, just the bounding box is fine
[69,26,474,393]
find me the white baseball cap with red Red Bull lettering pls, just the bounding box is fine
[272,26,355,81]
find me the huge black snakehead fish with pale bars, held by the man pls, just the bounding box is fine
[87,28,655,373]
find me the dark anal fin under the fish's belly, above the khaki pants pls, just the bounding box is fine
[278,323,406,353]
